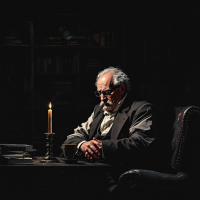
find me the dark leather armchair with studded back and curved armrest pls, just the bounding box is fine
[119,106,200,200]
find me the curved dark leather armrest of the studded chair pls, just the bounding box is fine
[119,169,189,189]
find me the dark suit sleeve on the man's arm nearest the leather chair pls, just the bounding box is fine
[102,104,155,163]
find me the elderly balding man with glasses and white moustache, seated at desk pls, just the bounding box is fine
[61,67,155,198]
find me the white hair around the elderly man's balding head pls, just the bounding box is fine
[95,66,130,92]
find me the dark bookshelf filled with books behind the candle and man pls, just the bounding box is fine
[0,10,123,154]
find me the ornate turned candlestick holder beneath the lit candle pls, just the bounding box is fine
[40,133,59,163]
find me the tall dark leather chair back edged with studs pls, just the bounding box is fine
[171,106,200,175]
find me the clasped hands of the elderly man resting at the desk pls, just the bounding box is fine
[80,138,102,161]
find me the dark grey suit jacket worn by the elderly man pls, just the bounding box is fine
[61,95,155,168]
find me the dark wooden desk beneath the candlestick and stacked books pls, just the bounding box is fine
[0,157,111,200]
